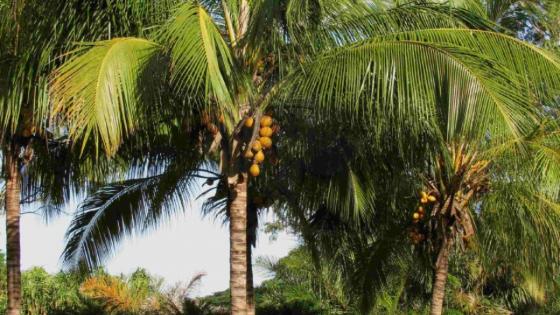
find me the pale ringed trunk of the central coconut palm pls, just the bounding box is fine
[229,173,247,315]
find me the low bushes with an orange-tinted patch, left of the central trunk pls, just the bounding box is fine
[0,253,211,315]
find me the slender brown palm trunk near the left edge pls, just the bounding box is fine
[4,146,21,315]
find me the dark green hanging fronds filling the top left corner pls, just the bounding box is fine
[0,0,179,141]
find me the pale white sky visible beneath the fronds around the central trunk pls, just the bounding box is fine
[0,201,298,296]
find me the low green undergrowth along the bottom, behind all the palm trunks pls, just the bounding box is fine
[0,247,560,315]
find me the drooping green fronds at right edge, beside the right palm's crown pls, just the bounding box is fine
[478,182,560,282]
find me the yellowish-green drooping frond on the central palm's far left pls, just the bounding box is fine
[51,38,160,154]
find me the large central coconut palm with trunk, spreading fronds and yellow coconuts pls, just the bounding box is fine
[51,0,560,314]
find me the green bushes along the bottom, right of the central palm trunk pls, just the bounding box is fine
[202,247,560,315]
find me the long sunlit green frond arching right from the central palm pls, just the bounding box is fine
[285,30,560,141]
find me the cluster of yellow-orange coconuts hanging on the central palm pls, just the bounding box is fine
[245,115,274,177]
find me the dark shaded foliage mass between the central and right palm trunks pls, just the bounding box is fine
[254,103,432,314]
